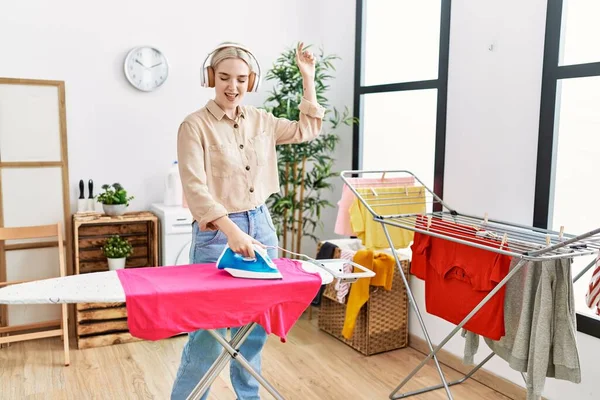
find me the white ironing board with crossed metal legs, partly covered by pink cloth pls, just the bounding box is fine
[0,260,374,400]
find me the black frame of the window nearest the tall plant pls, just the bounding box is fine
[352,0,452,211]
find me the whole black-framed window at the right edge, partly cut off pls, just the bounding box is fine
[534,0,600,337]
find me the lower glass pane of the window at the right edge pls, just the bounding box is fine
[550,77,600,315]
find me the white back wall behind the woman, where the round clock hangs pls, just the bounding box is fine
[0,0,354,260]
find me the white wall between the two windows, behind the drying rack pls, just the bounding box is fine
[410,0,600,399]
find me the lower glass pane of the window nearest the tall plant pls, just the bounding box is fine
[361,89,437,200]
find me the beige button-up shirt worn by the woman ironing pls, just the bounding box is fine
[177,98,325,230]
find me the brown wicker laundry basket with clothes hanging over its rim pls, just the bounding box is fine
[317,243,409,356]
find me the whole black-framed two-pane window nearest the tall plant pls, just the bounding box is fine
[352,0,450,195]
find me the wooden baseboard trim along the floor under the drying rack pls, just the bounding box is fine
[408,335,527,400]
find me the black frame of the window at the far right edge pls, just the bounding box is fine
[533,0,600,338]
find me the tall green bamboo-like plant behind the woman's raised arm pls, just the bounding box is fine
[264,46,358,253]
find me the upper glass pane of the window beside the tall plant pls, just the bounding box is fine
[362,0,442,86]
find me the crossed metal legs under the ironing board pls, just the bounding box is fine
[188,322,284,400]
